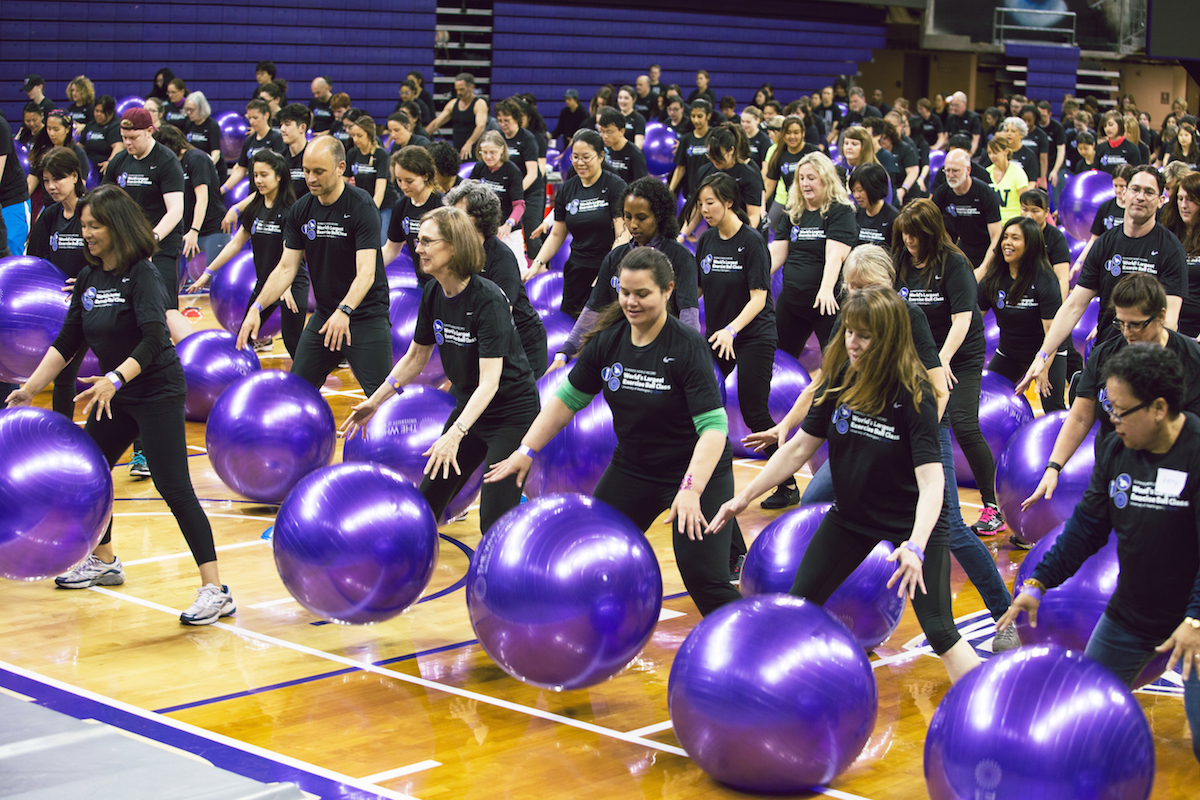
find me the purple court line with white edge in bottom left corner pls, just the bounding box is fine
[0,662,408,800]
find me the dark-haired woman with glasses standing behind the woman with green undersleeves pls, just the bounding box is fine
[524,130,628,319]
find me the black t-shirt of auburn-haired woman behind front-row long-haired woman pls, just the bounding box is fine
[896,253,984,368]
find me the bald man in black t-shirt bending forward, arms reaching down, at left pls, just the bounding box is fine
[238,137,392,397]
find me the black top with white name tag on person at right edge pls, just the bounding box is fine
[1033,414,1200,639]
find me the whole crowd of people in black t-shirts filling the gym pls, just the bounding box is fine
[0,61,1200,758]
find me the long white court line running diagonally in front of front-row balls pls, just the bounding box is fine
[89,587,688,758]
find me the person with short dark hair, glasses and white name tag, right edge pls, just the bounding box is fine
[997,344,1200,759]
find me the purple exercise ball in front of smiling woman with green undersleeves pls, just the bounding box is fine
[467,494,662,691]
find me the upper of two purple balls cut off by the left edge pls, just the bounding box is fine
[0,255,71,384]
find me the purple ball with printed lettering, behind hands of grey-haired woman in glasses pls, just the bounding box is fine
[342,384,484,521]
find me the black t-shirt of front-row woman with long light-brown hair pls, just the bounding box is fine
[800,374,947,545]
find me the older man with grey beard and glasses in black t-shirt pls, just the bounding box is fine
[932,149,1001,272]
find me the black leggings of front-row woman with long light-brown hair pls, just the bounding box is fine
[792,515,962,655]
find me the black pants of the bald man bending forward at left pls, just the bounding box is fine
[292,312,388,398]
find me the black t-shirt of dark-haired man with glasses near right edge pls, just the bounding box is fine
[1078,222,1188,343]
